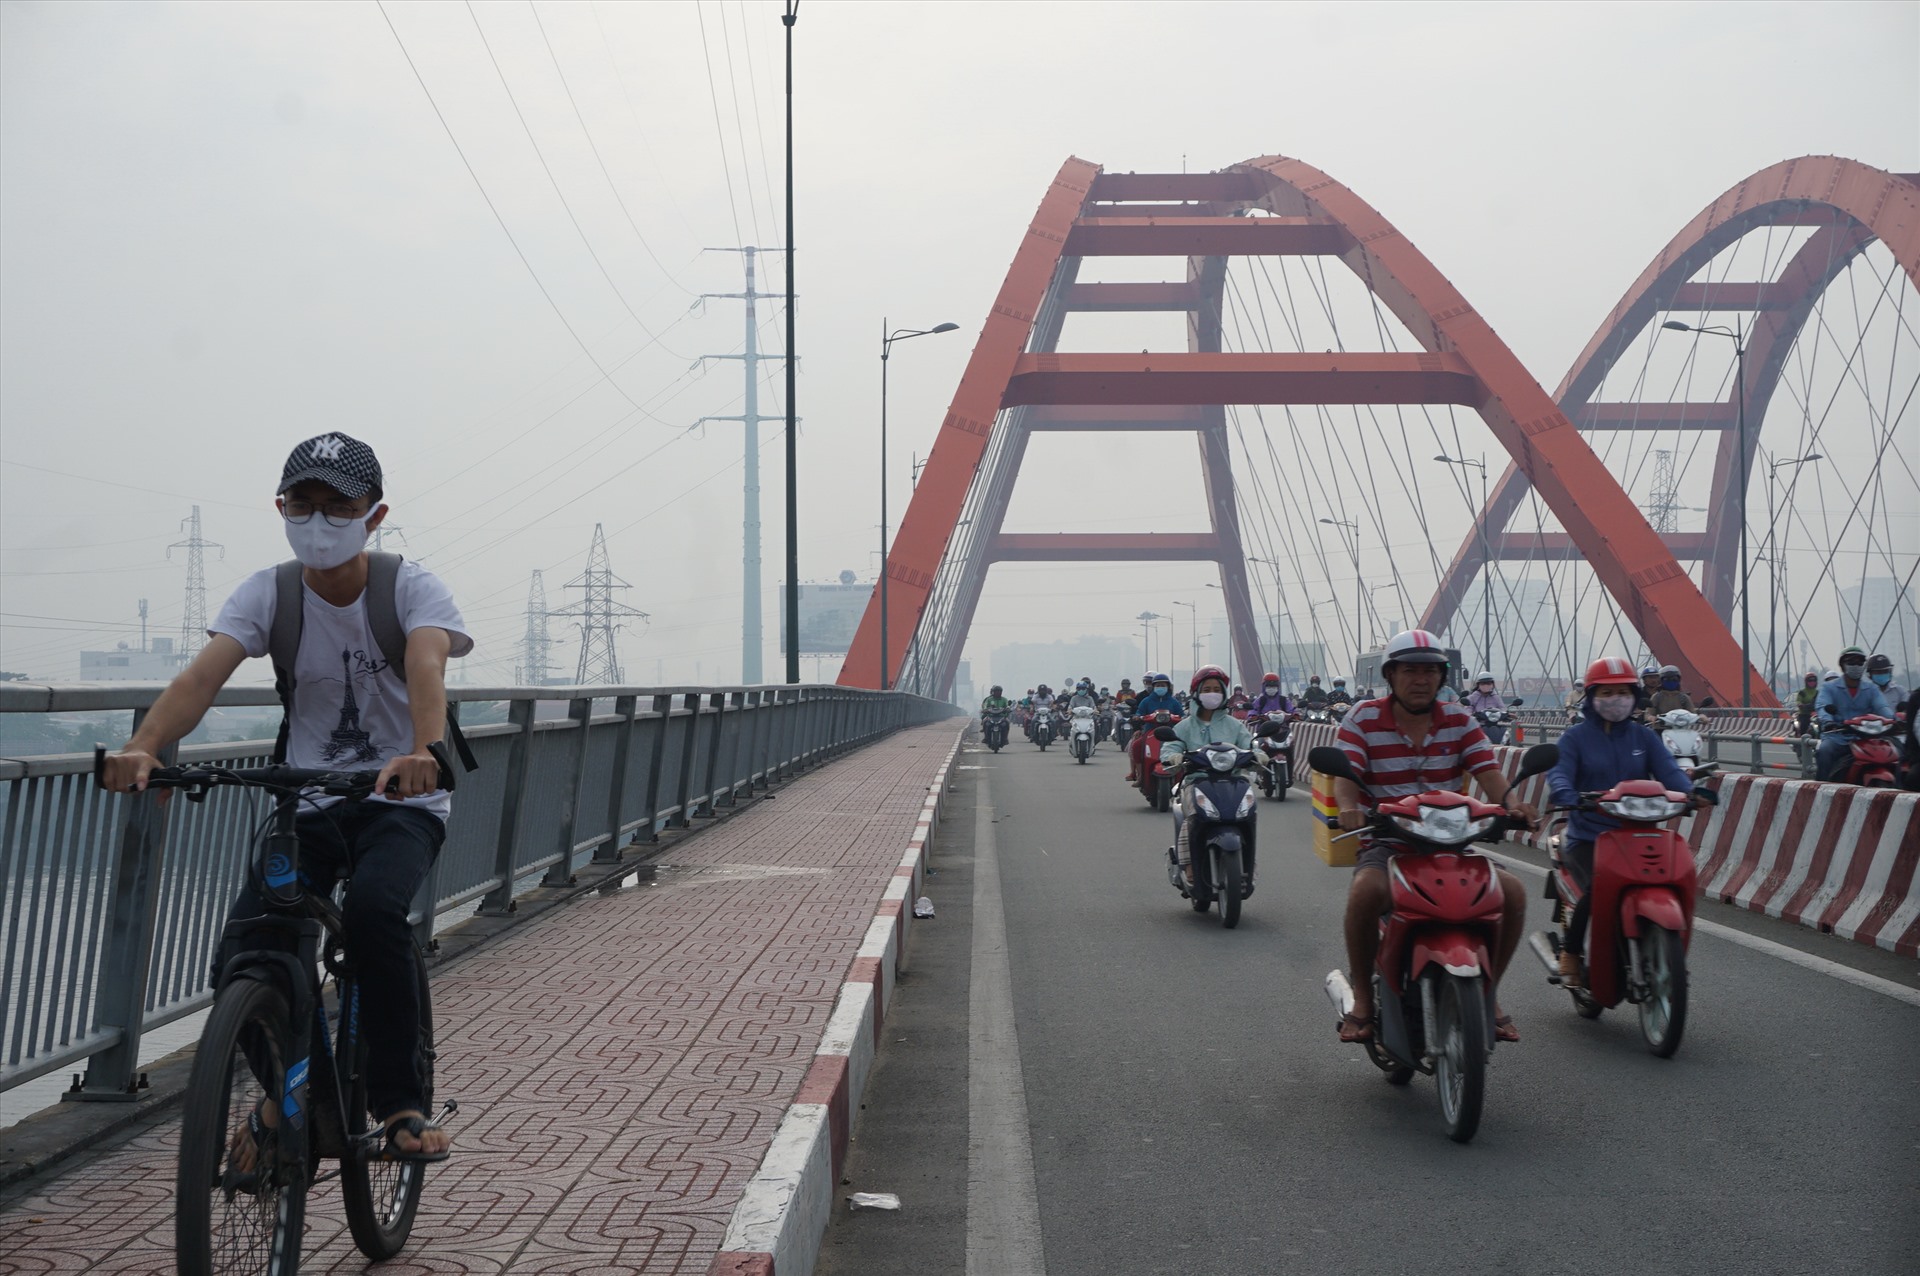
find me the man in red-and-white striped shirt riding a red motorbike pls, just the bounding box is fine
[1332,629,1538,1042]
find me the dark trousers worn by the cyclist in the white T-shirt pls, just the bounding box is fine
[213,800,447,1121]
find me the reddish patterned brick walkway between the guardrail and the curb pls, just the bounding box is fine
[0,720,964,1276]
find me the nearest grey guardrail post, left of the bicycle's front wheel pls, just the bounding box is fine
[61,710,179,1103]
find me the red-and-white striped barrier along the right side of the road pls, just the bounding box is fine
[1294,725,1920,957]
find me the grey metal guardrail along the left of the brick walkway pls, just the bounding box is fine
[0,683,958,1099]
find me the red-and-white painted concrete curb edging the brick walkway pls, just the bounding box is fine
[707,733,966,1276]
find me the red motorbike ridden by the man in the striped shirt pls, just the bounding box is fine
[1308,744,1559,1144]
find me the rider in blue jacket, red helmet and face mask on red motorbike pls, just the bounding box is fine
[1548,656,1703,984]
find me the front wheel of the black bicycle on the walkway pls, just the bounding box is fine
[173,979,307,1276]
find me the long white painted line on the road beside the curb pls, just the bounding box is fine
[966,775,1046,1276]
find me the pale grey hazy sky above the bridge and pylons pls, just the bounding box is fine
[0,0,1920,698]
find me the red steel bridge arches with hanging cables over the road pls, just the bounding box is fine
[839,157,1920,706]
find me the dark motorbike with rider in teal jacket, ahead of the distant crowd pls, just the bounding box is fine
[1154,727,1258,931]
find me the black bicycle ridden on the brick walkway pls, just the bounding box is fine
[94,744,459,1276]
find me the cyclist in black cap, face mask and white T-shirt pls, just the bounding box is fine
[102,434,474,1161]
